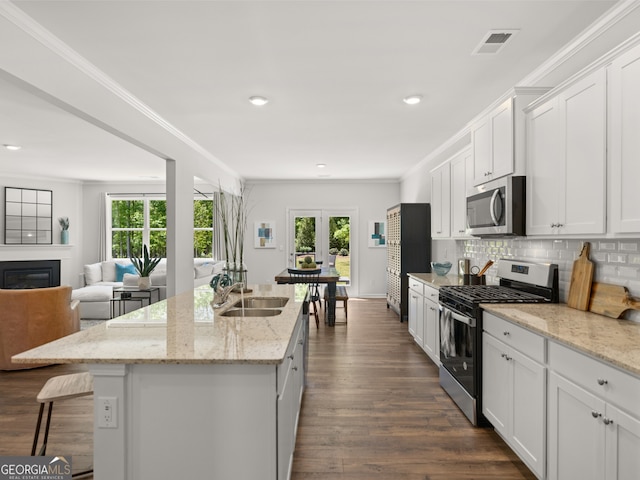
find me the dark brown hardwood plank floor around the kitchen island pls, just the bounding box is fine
[0,299,535,480]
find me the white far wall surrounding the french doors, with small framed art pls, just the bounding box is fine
[245,181,400,296]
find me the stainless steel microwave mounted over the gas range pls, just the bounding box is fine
[467,176,526,237]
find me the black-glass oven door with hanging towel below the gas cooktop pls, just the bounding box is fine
[440,306,477,398]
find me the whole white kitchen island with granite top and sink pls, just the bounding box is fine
[14,285,308,480]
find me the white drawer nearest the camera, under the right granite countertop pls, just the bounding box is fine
[549,341,640,417]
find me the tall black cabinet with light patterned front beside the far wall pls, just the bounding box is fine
[387,203,431,322]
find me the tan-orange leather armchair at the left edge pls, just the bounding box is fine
[0,286,80,370]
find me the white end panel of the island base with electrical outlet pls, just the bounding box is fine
[90,365,286,480]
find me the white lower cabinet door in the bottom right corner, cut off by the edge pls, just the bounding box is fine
[605,405,640,480]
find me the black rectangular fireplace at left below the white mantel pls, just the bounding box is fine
[0,260,60,289]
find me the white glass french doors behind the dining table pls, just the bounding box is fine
[287,209,358,289]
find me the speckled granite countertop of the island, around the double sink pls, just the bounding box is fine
[13,285,307,364]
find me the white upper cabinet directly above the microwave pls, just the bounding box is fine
[471,87,548,185]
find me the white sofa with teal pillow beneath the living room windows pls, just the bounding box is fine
[71,258,225,319]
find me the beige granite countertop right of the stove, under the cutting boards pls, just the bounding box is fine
[481,303,640,376]
